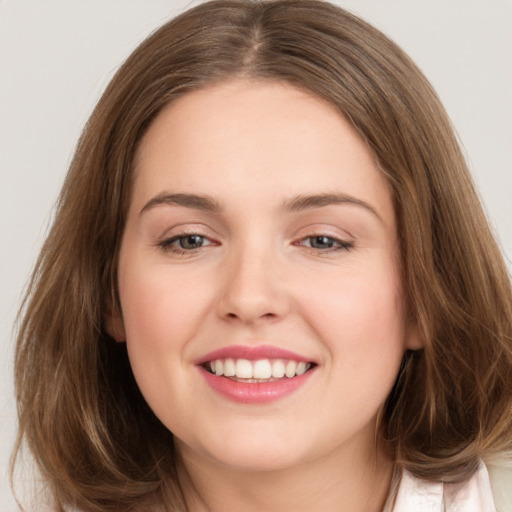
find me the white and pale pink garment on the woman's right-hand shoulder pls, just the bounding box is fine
[391,459,512,512]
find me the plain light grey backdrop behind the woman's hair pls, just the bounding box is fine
[0,0,512,512]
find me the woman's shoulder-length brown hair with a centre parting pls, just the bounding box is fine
[12,0,512,511]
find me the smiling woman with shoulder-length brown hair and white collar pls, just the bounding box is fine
[12,0,512,512]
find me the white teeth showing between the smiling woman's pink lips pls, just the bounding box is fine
[202,358,315,383]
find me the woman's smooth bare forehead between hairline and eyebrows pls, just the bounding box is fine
[134,80,393,223]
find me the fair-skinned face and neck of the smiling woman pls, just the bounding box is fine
[110,80,418,512]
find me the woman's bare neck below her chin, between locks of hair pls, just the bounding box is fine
[175,438,393,512]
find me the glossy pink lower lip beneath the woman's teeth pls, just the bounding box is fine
[199,367,313,404]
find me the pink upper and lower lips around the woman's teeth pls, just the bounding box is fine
[195,345,315,404]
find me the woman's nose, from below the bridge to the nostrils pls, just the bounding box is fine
[217,243,290,325]
